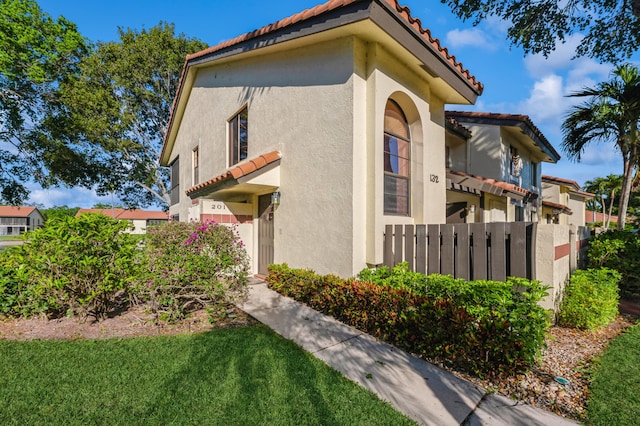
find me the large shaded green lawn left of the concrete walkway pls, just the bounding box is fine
[0,325,413,425]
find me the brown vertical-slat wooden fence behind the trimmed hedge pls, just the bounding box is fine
[384,222,537,281]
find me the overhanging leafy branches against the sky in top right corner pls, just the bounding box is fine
[440,0,640,63]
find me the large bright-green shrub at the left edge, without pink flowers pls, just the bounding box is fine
[0,214,136,318]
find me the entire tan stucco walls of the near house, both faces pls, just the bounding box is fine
[170,37,446,277]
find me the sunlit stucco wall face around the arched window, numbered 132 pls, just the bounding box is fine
[359,40,446,265]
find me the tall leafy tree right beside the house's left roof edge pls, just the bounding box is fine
[52,22,206,210]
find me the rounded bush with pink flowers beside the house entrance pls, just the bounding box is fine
[135,222,249,321]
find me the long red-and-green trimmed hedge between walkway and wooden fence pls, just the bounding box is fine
[267,264,550,376]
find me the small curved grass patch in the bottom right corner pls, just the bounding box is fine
[587,326,640,426]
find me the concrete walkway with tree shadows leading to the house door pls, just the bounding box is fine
[241,280,577,426]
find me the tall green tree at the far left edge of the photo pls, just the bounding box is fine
[0,0,93,204]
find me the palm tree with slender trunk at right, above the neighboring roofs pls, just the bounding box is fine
[562,64,640,230]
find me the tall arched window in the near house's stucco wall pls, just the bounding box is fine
[384,99,411,216]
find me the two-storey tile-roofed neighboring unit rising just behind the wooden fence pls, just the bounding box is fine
[445,111,560,223]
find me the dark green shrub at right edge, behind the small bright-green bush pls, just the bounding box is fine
[587,231,640,296]
